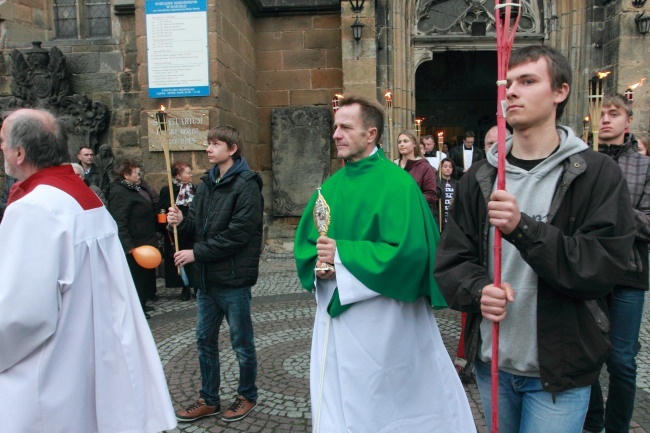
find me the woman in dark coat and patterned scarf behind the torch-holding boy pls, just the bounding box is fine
[158,161,196,301]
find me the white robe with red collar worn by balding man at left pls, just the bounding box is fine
[0,185,176,433]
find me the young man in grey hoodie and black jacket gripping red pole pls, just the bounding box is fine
[435,46,635,433]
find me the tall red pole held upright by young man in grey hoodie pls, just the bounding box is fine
[490,0,521,433]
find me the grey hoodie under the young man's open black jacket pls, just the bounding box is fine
[479,126,588,377]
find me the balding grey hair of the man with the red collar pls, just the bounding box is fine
[5,108,70,170]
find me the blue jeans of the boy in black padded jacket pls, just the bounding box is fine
[196,287,257,406]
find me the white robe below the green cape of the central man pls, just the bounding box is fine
[310,254,476,433]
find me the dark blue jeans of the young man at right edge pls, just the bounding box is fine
[585,286,645,433]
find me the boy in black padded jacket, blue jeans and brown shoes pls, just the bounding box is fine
[167,125,264,422]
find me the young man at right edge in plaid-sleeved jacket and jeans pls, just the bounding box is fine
[585,93,650,433]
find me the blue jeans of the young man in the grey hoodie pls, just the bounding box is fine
[475,359,590,433]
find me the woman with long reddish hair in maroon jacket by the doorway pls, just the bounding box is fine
[395,130,439,215]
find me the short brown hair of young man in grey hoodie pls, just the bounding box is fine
[508,45,571,120]
